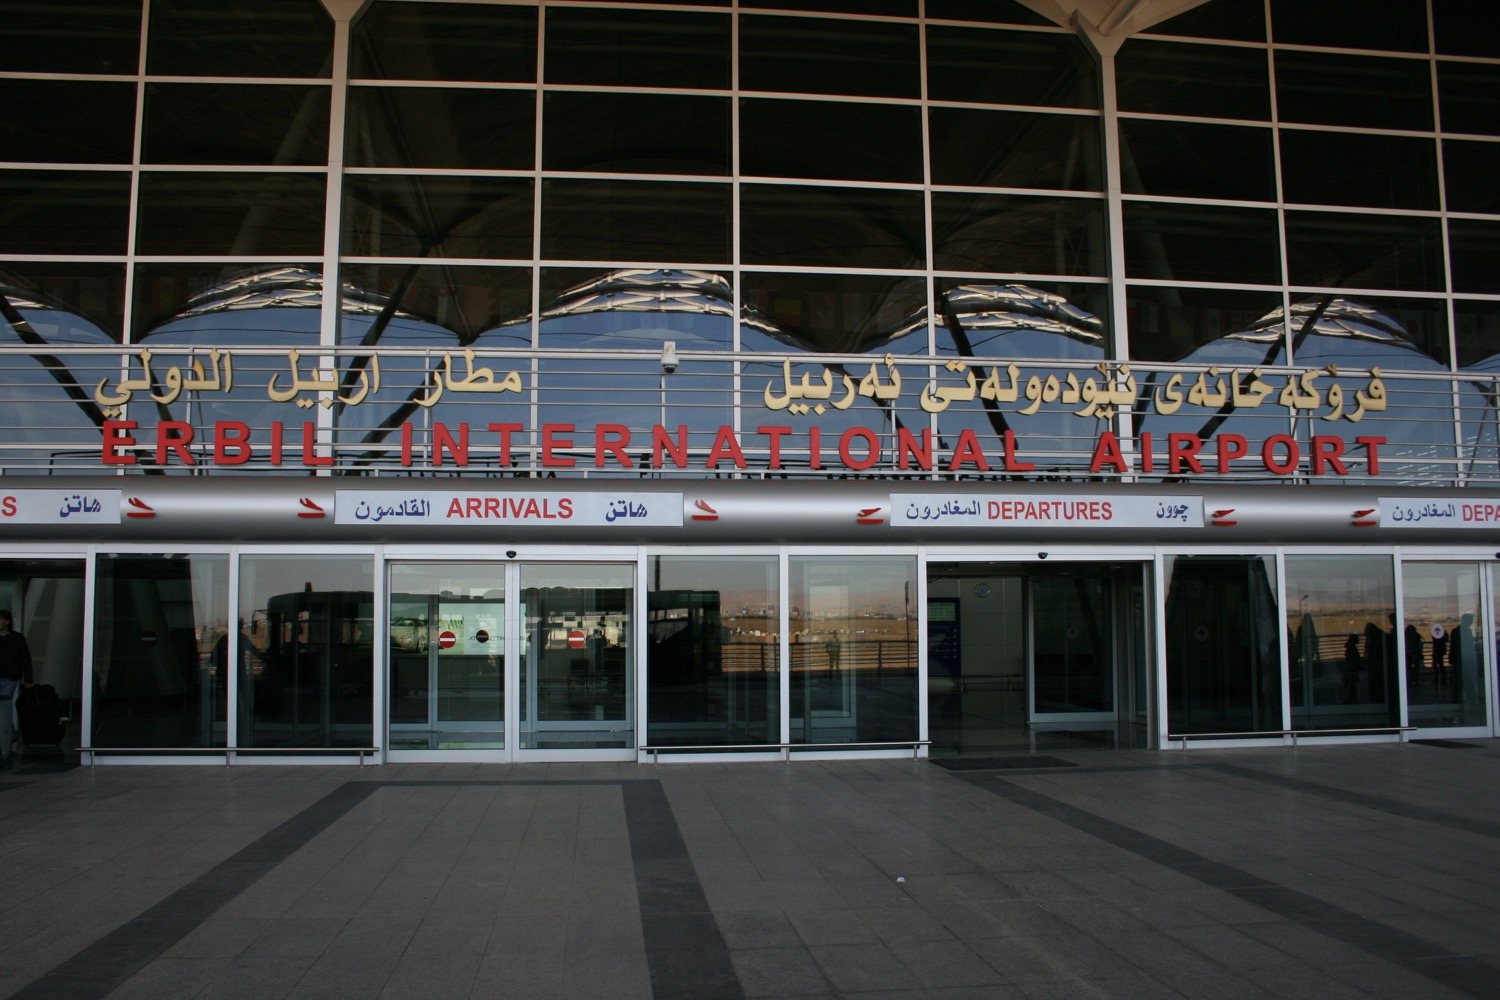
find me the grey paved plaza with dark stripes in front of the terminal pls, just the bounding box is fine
[0,741,1500,1000]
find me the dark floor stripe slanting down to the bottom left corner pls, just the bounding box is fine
[11,781,380,1000]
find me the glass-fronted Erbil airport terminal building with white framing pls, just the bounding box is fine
[0,0,1500,763]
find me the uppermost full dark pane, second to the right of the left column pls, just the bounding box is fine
[545,7,731,88]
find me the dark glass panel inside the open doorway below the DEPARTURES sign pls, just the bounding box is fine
[1032,571,1115,714]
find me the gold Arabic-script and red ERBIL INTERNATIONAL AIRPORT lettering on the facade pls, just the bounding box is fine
[93,349,1389,477]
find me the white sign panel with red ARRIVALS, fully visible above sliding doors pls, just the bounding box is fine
[333,490,683,528]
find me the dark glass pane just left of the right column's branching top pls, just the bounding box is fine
[930,25,1100,108]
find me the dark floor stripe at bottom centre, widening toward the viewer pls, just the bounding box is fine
[620,781,744,1000]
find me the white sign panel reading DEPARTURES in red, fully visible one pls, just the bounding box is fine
[891,493,1203,528]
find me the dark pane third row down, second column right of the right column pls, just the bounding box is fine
[1281,129,1439,211]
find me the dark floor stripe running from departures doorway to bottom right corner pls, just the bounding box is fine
[957,775,1500,997]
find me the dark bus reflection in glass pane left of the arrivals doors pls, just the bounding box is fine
[239,591,374,748]
